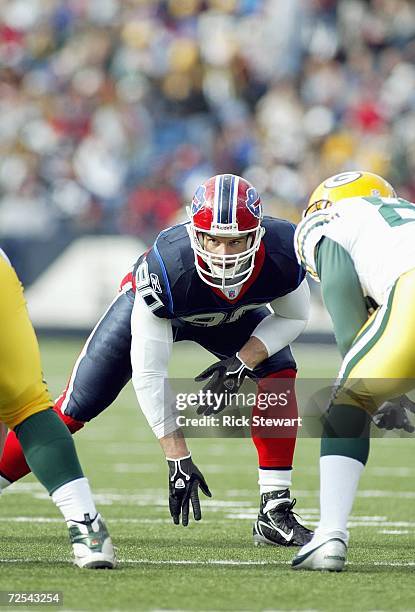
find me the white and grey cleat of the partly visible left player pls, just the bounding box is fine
[69,514,117,569]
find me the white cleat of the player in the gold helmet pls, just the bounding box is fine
[291,538,347,572]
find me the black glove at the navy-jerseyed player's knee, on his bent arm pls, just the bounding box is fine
[195,353,252,416]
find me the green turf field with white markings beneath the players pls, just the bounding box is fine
[0,341,415,611]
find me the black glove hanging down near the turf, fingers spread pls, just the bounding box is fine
[167,455,212,527]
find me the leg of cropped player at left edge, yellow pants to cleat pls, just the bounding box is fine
[0,249,116,569]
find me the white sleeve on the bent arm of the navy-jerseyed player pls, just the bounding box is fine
[252,279,310,357]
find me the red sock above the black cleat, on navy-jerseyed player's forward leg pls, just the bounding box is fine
[251,368,298,469]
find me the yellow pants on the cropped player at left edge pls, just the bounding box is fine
[0,255,53,429]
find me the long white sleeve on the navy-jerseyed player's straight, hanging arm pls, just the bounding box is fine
[131,294,178,438]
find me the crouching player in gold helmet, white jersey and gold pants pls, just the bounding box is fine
[292,172,415,571]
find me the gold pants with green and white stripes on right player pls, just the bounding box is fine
[335,269,415,413]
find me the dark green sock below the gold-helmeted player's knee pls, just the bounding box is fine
[320,404,370,465]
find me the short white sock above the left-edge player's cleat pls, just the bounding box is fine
[52,478,97,522]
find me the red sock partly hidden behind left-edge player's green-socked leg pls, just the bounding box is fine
[0,405,84,482]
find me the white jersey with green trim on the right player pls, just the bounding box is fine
[294,197,415,305]
